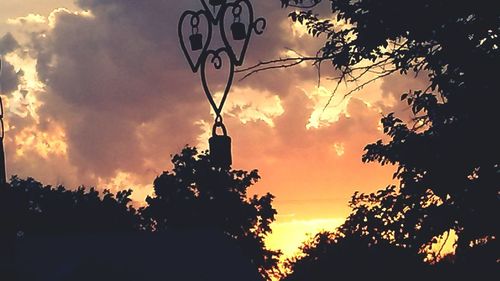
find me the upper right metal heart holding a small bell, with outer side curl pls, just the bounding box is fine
[219,0,266,66]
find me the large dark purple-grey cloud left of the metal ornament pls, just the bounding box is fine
[31,1,208,178]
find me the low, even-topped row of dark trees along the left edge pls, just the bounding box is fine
[0,176,140,236]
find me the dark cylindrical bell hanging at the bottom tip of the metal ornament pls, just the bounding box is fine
[208,123,233,168]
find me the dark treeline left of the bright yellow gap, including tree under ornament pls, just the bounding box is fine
[0,147,280,280]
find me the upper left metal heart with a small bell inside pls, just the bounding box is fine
[178,10,212,72]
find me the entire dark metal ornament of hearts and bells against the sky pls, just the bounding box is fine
[178,0,266,168]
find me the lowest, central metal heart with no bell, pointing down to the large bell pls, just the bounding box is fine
[201,48,234,117]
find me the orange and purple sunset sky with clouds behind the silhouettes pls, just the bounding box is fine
[0,0,426,255]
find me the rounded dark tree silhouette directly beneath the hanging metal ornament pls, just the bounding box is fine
[141,147,279,278]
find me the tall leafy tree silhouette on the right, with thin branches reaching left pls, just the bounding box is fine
[266,0,500,280]
